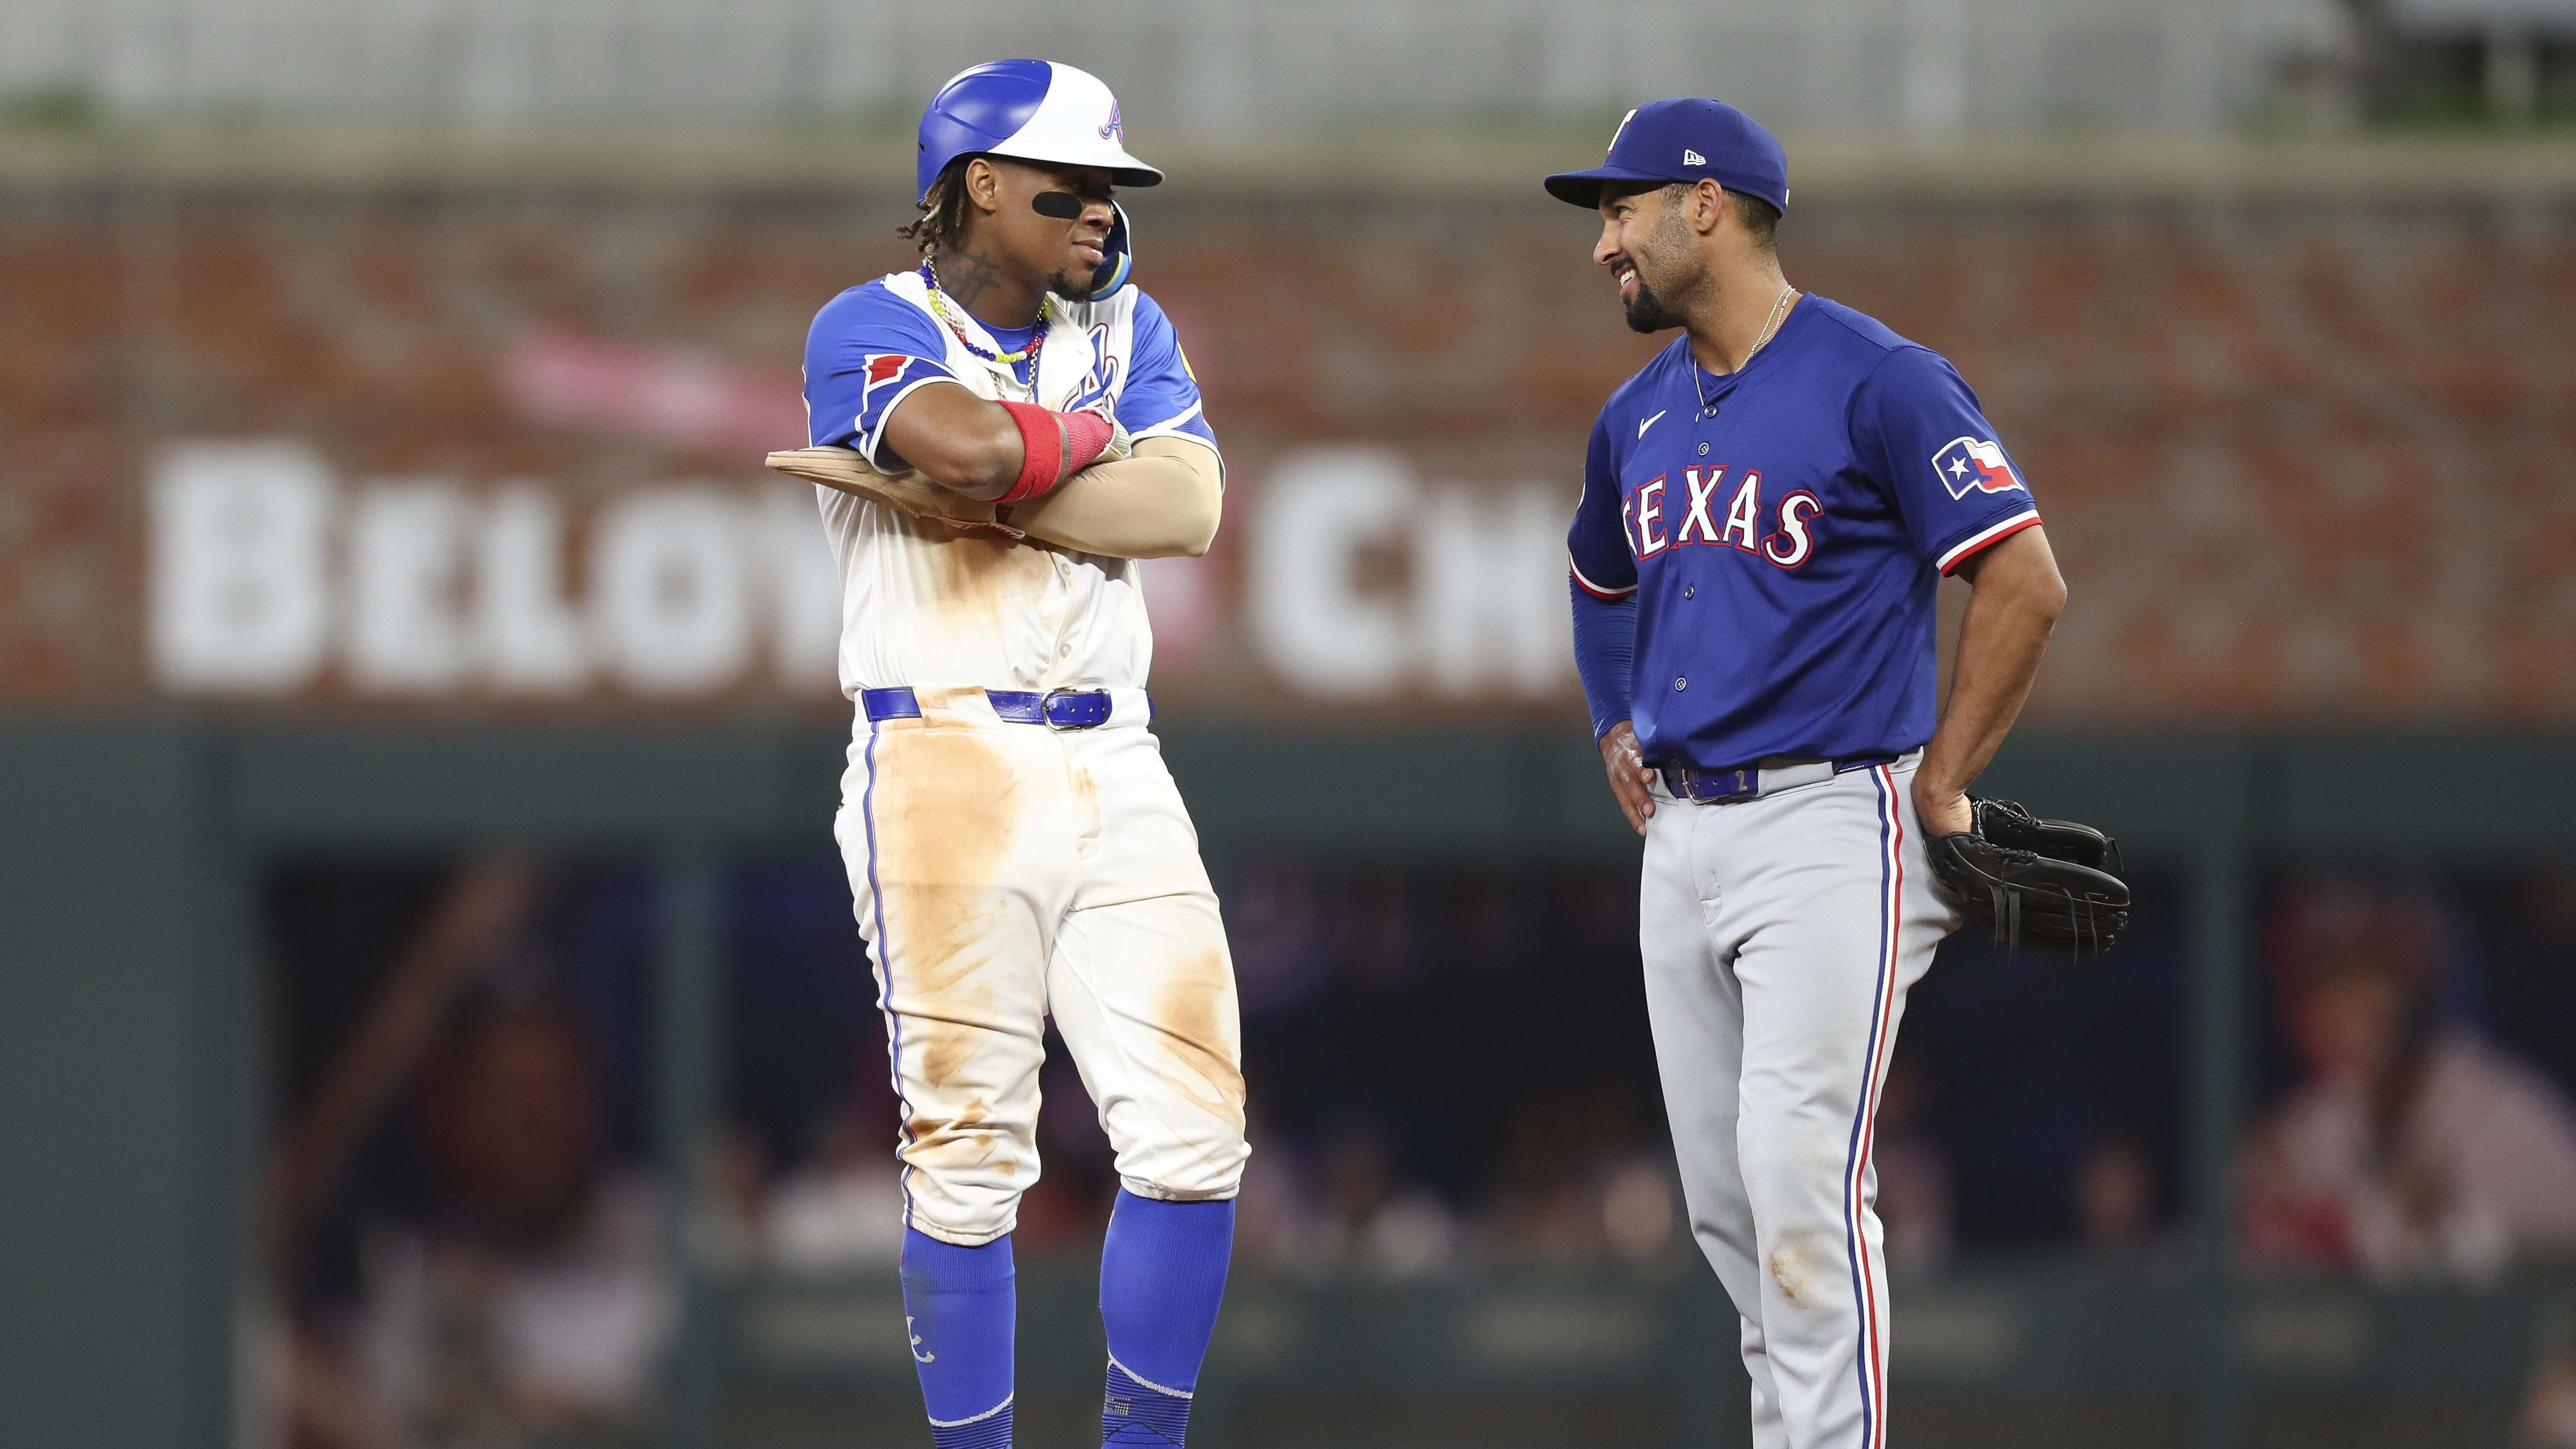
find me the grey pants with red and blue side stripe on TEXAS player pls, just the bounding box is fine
[1638,758,1958,1449]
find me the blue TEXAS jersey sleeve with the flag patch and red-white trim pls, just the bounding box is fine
[1852,348,2040,572]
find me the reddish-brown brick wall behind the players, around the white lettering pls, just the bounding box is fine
[0,188,2576,725]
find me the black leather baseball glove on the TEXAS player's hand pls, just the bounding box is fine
[1929,799,2128,957]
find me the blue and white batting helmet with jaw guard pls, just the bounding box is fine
[914,60,1162,302]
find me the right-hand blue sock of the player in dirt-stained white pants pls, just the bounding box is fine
[1097,1189,1234,1449]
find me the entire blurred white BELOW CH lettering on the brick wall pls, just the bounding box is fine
[147,441,1574,701]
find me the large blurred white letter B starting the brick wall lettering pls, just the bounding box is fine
[147,441,332,693]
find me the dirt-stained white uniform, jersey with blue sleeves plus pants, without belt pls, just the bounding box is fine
[806,273,1247,1245]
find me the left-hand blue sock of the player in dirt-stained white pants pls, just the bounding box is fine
[904,1227,1020,1449]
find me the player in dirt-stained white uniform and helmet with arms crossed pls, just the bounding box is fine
[806,60,1247,1449]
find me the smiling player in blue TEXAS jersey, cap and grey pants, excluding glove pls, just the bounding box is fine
[1546,98,2066,1449]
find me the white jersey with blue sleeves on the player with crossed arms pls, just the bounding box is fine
[806,271,1216,699]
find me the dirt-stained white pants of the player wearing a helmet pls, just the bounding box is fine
[832,688,1247,1248]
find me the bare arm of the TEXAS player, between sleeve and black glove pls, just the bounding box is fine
[1917,529,2066,797]
